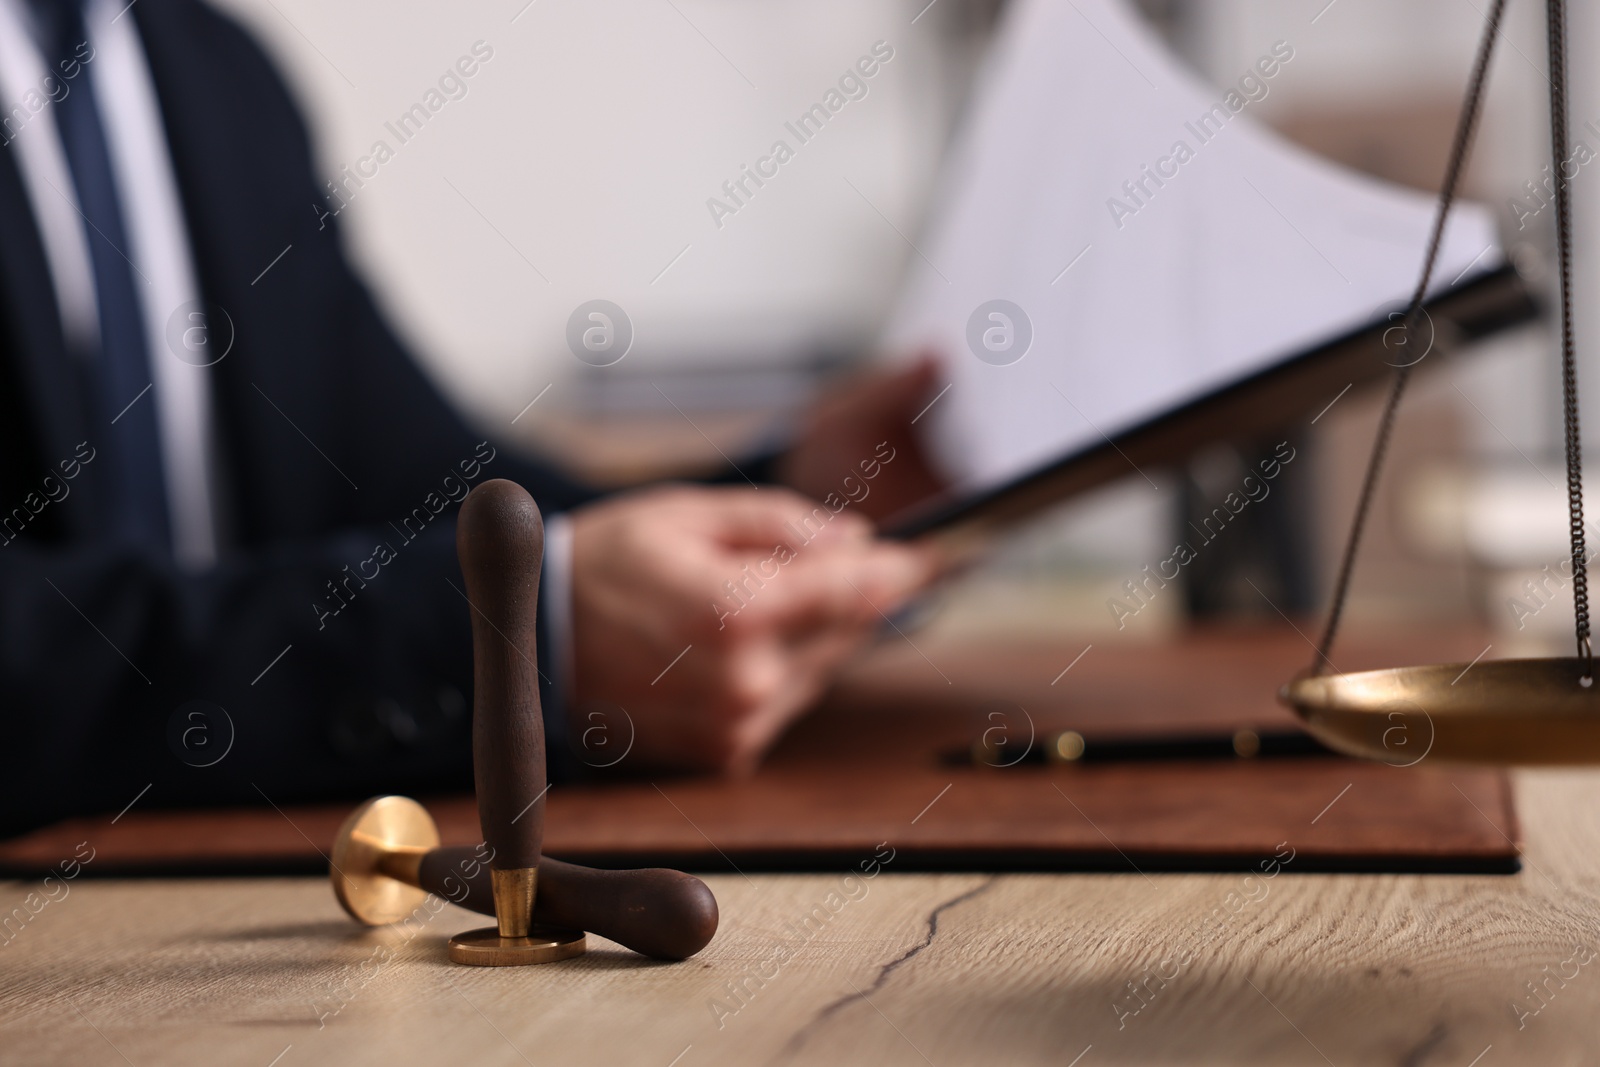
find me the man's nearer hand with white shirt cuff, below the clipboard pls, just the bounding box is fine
[573,486,934,771]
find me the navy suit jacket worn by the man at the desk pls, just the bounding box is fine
[0,0,604,833]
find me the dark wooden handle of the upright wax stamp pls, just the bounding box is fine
[456,478,546,870]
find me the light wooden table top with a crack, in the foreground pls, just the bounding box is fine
[0,771,1600,1067]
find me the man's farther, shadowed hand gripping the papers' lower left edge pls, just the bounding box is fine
[778,355,944,520]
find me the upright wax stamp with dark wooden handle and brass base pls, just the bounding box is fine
[450,478,584,966]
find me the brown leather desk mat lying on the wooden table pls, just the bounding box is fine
[0,630,1520,873]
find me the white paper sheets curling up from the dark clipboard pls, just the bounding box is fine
[885,0,1504,494]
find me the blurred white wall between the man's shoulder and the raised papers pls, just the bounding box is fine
[208,0,963,424]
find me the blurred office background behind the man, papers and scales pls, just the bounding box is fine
[222,0,1600,653]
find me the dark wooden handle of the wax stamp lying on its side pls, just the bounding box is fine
[416,846,718,960]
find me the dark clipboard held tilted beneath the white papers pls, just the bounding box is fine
[882,264,1538,542]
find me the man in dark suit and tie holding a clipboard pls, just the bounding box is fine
[0,0,933,832]
